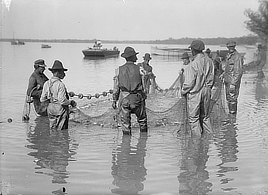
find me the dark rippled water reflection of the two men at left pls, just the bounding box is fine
[26,117,76,184]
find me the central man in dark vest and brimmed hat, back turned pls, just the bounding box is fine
[112,47,148,135]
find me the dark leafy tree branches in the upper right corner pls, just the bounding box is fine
[245,0,268,44]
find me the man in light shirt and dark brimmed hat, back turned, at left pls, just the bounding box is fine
[40,60,76,130]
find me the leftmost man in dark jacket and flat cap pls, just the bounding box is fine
[26,59,48,116]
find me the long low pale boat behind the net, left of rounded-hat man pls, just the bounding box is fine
[151,46,192,57]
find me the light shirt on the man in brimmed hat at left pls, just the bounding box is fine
[40,76,70,105]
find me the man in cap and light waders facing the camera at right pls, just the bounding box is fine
[220,41,243,115]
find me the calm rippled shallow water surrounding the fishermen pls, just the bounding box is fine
[0,42,268,195]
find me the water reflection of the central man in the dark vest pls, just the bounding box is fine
[111,133,147,194]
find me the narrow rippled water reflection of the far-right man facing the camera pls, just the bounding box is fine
[216,119,238,190]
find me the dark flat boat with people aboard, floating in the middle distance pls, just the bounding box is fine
[82,41,120,57]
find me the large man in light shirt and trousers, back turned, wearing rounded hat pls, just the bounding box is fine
[181,40,214,136]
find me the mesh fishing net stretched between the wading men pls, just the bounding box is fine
[71,74,226,132]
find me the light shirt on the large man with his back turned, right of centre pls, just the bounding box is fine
[182,53,214,94]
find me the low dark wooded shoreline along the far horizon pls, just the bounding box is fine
[0,35,258,45]
